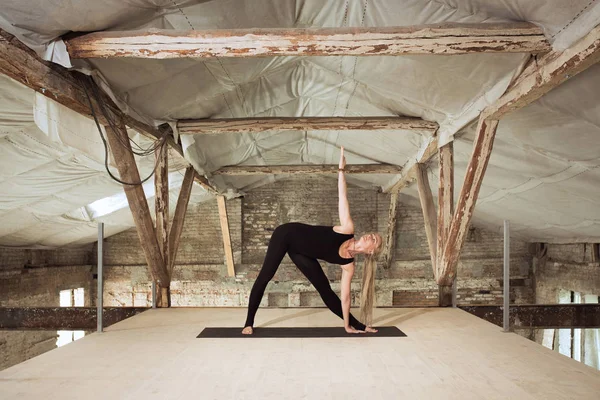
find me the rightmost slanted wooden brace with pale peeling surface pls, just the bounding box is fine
[437,119,498,286]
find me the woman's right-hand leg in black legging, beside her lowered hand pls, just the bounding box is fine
[288,253,366,331]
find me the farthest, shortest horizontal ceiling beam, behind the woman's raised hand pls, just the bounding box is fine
[213,164,402,175]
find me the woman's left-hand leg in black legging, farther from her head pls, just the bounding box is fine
[242,225,288,334]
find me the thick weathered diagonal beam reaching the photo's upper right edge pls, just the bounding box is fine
[481,26,600,120]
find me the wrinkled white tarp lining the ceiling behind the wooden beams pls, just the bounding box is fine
[0,0,600,245]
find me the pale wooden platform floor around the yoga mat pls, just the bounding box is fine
[0,308,600,400]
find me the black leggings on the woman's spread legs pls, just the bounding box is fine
[244,229,365,330]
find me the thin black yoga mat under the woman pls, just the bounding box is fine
[196,326,406,338]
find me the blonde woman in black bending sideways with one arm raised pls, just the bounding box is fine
[242,147,382,335]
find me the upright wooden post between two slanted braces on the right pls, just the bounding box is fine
[434,142,456,307]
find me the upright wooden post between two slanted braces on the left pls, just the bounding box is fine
[154,146,171,307]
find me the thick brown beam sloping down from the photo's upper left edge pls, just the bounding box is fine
[0,29,217,194]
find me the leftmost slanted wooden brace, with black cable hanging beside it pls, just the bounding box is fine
[106,116,171,288]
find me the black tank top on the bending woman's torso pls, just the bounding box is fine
[280,222,354,265]
